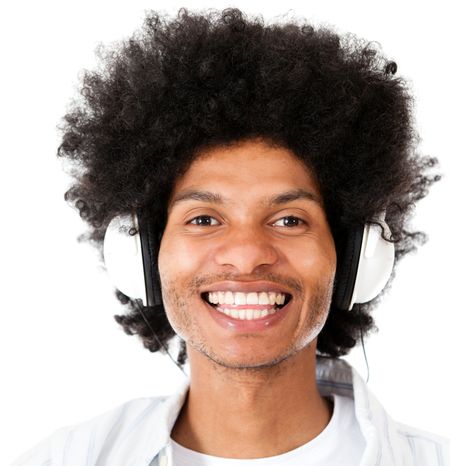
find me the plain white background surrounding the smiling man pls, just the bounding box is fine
[0,0,450,464]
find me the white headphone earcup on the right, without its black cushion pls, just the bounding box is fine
[349,218,395,310]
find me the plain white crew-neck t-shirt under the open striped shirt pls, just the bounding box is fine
[170,394,366,466]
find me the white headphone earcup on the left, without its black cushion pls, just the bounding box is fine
[103,215,146,302]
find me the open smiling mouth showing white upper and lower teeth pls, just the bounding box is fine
[201,292,292,320]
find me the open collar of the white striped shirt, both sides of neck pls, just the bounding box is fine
[139,356,402,466]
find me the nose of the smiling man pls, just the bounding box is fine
[215,225,279,275]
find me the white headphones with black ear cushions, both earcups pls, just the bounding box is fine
[103,211,395,311]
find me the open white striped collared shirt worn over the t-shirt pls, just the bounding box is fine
[12,356,450,466]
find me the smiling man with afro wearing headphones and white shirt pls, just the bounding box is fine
[12,9,450,466]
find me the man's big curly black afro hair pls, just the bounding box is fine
[58,8,440,363]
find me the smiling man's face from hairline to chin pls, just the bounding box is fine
[158,140,336,367]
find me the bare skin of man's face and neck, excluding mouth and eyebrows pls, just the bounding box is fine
[158,139,336,459]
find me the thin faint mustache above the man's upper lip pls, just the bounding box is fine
[188,273,304,295]
